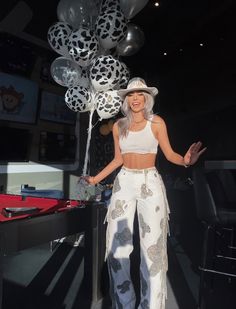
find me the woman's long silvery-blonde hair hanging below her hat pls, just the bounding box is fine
[117,91,154,136]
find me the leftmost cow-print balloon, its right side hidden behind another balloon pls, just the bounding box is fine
[47,22,72,56]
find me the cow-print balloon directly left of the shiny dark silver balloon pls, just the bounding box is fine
[95,9,128,49]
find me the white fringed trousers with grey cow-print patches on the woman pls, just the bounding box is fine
[106,167,169,309]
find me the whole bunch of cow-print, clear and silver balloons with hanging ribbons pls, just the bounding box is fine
[48,0,148,197]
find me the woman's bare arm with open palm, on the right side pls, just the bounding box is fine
[153,116,206,167]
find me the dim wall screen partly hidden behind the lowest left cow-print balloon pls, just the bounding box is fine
[40,90,76,124]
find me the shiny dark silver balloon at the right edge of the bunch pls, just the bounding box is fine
[116,23,145,56]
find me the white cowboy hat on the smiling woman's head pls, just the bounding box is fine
[117,77,158,99]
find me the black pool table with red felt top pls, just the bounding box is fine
[0,194,106,309]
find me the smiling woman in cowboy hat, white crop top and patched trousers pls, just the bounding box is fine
[87,77,206,309]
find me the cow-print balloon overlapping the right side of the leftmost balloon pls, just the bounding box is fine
[68,27,99,67]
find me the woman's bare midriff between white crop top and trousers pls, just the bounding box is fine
[122,153,156,169]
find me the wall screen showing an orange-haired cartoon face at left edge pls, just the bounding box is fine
[0,72,38,123]
